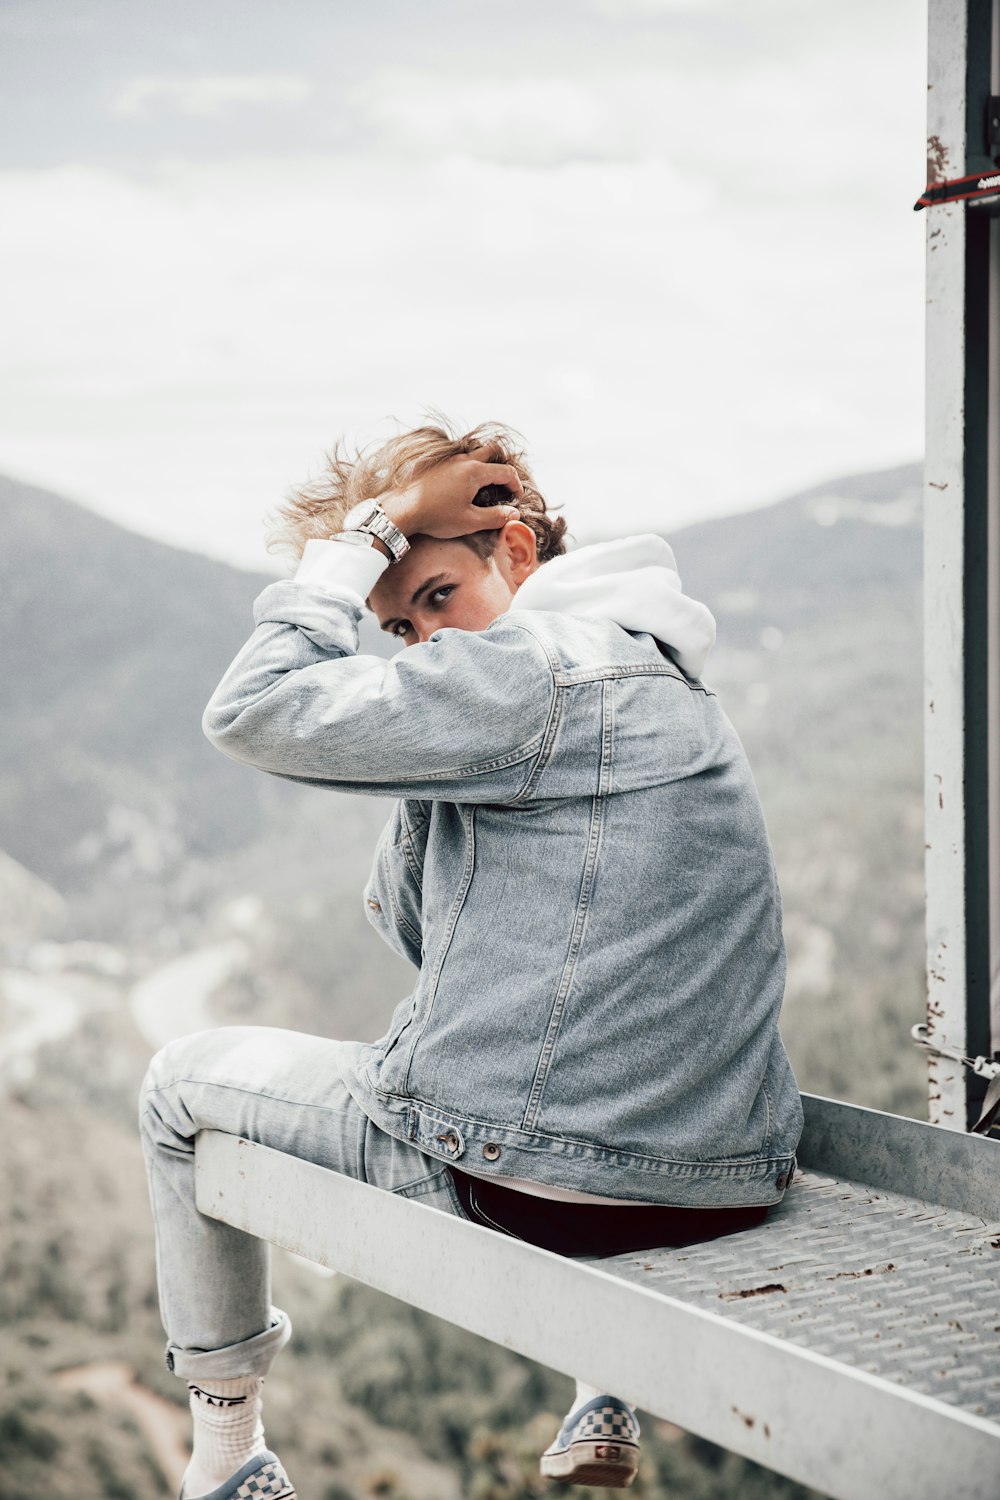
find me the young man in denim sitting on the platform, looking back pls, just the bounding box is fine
[141,426,802,1500]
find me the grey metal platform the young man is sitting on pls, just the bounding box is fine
[196,1095,1000,1500]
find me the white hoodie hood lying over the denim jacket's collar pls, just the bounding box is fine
[510,534,715,677]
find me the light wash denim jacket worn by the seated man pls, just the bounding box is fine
[204,537,802,1208]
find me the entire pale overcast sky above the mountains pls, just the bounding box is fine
[0,0,927,566]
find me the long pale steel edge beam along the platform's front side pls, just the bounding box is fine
[196,1133,1000,1500]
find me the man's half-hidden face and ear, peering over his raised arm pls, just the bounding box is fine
[369,522,537,647]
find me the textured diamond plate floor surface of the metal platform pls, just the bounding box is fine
[594,1172,1000,1421]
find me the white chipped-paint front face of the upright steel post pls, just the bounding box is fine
[924,0,969,1131]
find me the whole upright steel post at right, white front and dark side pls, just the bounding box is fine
[924,0,997,1131]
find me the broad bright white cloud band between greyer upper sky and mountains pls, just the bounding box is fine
[0,141,922,564]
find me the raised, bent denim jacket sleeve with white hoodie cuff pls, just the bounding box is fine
[202,567,555,803]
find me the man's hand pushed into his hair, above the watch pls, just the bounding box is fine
[378,447,523,540]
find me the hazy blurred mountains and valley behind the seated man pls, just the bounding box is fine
[0,467,927,1500]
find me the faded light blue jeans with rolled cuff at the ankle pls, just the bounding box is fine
[139,1026,466,1380]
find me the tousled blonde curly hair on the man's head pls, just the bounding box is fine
[267,414,567,563]
